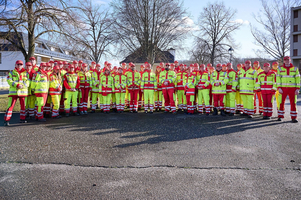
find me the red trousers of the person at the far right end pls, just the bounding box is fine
[278,87,298,119]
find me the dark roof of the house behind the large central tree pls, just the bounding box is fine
[121,47,175,63]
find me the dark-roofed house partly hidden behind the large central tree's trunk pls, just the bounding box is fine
[121,48,176,71]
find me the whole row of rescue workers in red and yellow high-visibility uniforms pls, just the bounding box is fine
[4,56,300,126]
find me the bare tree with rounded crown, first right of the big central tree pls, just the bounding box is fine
[198,2,241,65]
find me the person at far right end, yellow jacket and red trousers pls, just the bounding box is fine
[277,56,300,123]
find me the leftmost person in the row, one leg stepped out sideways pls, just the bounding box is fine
[4,60,30,126]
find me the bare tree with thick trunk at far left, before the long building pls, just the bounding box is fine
[0,0,73,61]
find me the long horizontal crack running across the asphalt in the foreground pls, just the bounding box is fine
[0,161,301,171]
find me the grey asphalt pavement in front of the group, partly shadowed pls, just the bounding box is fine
[0,95,301,199]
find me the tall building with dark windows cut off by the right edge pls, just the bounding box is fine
[290,6,301,69]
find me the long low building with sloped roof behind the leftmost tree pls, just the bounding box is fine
[0,32,91,76]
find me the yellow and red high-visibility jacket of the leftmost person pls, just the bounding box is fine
[7,68,30,97]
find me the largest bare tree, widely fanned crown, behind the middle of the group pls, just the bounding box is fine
[111,0,189,63]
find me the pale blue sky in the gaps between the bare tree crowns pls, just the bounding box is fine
[94,0,268,65]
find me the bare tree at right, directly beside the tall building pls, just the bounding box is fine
[251,0,300,60]
